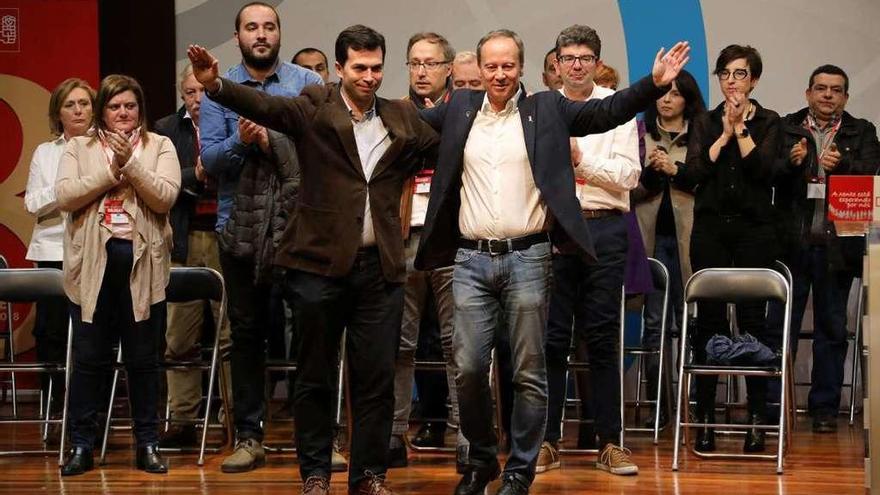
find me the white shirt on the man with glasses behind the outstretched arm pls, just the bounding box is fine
[559,84,642,212]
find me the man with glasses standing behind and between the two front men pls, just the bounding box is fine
[389,32,466,467]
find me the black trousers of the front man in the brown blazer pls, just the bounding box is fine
[286,248,403,486]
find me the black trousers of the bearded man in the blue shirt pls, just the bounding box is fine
[220,251,283,442]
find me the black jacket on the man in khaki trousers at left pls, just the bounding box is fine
[155,107,204,263]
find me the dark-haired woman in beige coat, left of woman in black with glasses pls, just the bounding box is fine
[633,70,706,428]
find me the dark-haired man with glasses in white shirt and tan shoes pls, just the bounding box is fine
[536,25,641,475]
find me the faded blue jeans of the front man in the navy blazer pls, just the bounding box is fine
[452,242,551,482]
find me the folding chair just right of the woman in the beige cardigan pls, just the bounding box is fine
[100,267,232,466]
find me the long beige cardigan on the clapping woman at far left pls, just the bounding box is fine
[55,133,180,323]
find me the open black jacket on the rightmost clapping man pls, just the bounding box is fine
[776,108,880,273]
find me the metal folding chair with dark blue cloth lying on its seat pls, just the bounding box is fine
[672,268,791,474]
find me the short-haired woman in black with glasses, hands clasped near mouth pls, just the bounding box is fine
[674,45,780,452]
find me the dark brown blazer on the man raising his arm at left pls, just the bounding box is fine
[209,79,439,283]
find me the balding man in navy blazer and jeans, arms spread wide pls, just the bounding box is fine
[415,29,689,495]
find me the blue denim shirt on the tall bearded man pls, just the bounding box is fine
[199,62,324,232]
